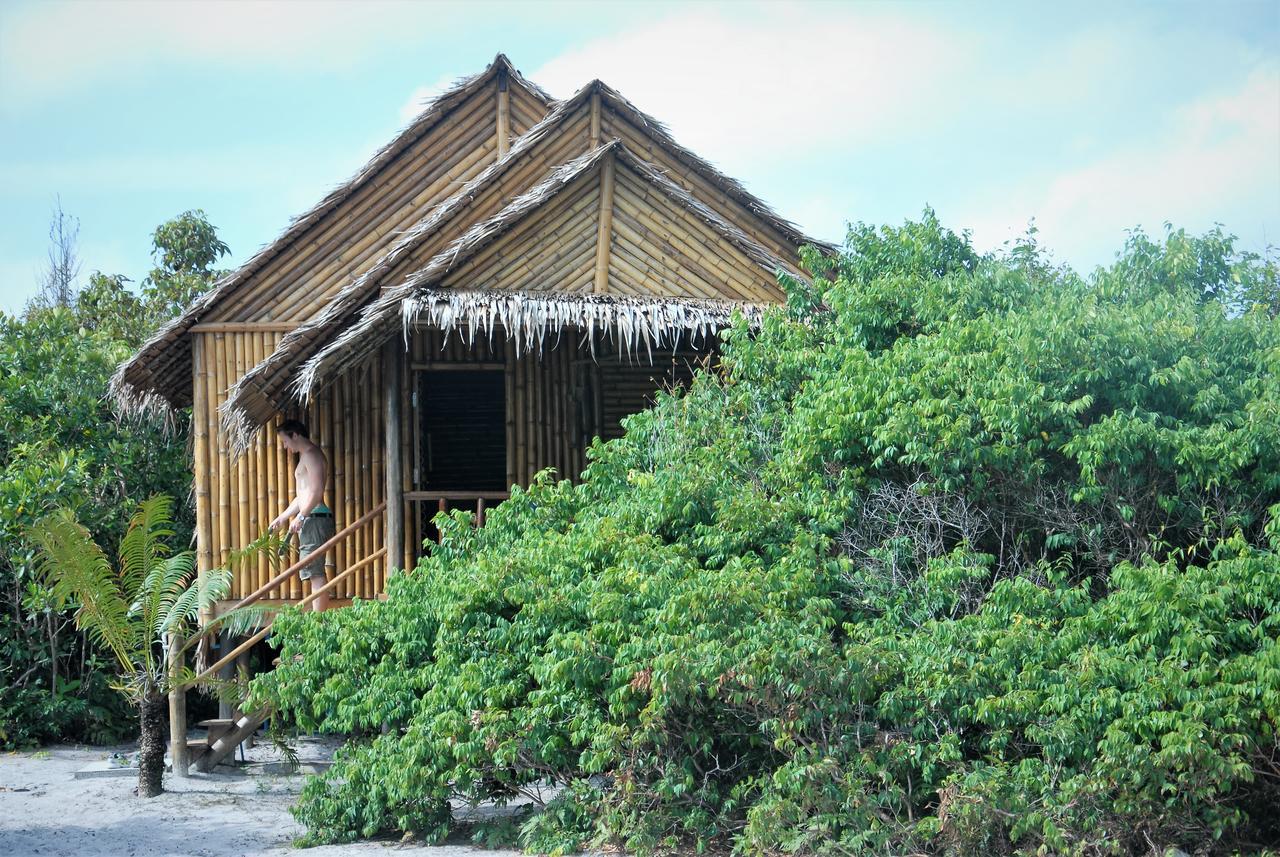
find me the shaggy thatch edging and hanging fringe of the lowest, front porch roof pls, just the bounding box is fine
[223,141,791,444]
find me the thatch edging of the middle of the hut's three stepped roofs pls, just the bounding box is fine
[218,81,835,447]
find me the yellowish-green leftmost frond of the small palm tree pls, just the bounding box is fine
[31,509,138,675]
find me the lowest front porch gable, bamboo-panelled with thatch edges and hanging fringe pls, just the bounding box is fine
[223,141,803,443]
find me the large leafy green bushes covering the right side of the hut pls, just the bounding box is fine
[253,214,1280,853]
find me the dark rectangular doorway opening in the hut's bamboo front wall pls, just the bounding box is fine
[417,370,509,491]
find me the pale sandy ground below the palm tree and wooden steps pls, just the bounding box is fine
[0,741,517,857]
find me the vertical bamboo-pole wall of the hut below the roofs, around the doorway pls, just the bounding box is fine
[193,325,716,611]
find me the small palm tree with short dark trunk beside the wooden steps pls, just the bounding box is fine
[32,495,239,797]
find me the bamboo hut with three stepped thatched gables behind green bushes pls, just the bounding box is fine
[113,55,817,621]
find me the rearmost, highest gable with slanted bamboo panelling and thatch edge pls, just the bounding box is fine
[111,54,553,413]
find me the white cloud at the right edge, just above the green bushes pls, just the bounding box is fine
[956,65,1280,265]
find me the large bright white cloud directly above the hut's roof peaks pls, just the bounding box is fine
[530,4,975,174]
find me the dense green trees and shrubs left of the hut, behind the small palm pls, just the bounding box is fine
[0,211,227,747]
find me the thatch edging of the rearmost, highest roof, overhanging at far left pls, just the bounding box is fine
[110,54,553,413]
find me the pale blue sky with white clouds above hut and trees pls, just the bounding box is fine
[0,0,1280,312]
